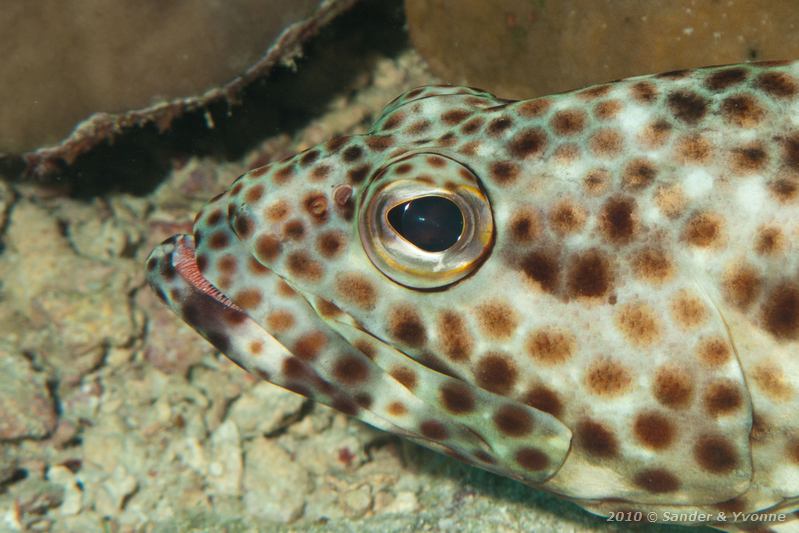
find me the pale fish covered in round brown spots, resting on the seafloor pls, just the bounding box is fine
[146,61,799,531]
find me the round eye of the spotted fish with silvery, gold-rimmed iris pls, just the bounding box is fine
[358,153,494,289]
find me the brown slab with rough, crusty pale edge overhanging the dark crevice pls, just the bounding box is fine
[12,0,354,173]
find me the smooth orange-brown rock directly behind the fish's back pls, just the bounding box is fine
[405,0,799,98]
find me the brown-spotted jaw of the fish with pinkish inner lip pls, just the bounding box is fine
[147,235,571,483]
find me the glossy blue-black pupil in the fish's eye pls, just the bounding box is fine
[388,196,463,252]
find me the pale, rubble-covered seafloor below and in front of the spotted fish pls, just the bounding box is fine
[0,4,712,533]
